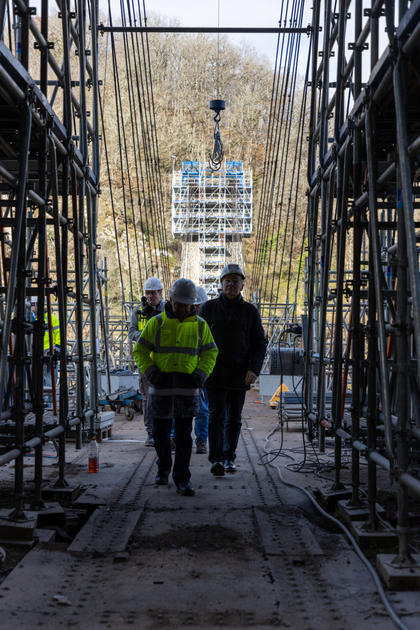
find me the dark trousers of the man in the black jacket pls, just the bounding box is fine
[207,389,246,463]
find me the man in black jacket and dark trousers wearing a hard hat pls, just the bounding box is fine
[200,263,266,476]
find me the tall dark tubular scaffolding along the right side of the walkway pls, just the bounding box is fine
[305,0,420,571]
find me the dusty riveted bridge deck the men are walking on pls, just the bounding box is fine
[0,392,420,630]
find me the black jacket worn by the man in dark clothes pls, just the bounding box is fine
[200,293,266,389]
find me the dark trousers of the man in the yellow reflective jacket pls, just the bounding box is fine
[153,417,193,484]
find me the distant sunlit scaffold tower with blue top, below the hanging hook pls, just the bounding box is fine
[172,161,252,297]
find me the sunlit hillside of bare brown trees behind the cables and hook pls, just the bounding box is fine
[98,19,306,300]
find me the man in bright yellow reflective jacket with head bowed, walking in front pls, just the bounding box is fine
[133,278,217,496]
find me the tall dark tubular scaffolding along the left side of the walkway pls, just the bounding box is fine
[0,0,99,519]
